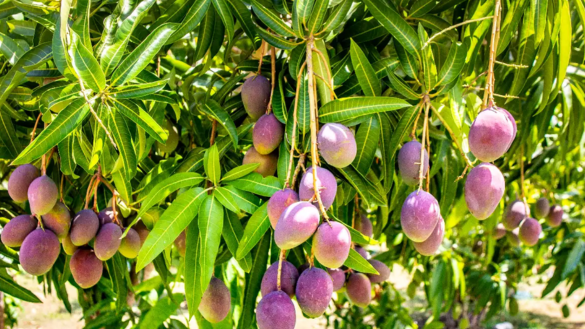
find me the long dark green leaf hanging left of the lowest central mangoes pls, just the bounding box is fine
[238,231,272,329]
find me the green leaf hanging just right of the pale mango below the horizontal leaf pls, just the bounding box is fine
[352,115,381,175]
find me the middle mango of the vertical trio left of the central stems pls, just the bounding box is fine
[252,113,284,154]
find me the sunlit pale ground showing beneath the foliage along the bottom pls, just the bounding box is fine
[15,265,585,329]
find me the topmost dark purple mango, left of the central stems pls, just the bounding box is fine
[240,75,272,120]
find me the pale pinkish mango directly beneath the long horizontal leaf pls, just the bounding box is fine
[317,123,357,168]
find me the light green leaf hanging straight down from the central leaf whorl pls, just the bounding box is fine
[198,194,224,291]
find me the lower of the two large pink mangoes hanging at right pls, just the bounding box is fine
[465,162,506,220]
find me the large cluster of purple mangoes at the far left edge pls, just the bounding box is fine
[1,164,144,288]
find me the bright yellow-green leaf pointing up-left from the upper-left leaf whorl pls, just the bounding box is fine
[69,32,106,93]
